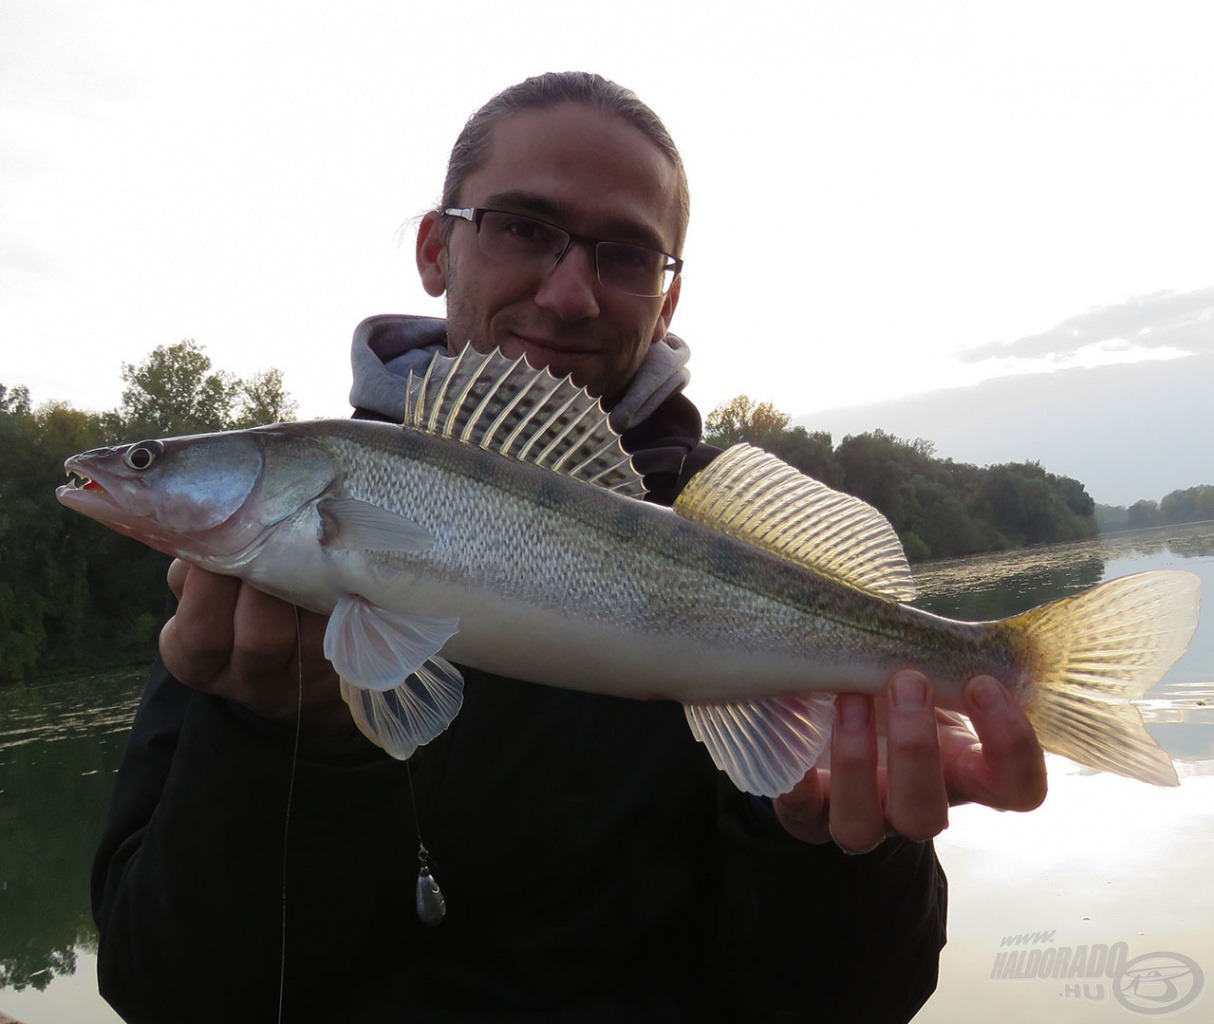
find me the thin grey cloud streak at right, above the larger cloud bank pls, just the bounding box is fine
[958,287,1214,369]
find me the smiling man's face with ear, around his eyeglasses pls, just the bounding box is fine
[418,103,679,396]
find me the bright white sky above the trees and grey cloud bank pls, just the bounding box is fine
[0,0,1214,482]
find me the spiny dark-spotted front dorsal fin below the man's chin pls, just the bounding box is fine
[403,345,645,498]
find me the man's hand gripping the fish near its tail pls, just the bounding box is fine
[773,671,1045,853]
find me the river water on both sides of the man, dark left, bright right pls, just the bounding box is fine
[0,524,1214,1024]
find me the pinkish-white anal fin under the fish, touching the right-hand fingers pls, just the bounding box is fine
[683,694,835,797]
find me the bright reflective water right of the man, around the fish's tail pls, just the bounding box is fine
[915,524,1214,1024]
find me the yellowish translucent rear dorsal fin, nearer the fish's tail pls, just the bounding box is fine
[675,445,914,601]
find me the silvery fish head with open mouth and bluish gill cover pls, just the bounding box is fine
[55,428,336,560]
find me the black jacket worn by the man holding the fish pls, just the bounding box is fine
[92,386,946,1024]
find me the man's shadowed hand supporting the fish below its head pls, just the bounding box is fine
[160,560,357,748]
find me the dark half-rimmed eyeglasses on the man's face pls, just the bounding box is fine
[443,207,682,299]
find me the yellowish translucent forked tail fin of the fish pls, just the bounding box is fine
[1000,571,1201,786]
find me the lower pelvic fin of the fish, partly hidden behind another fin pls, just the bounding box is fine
[341,657,464,760]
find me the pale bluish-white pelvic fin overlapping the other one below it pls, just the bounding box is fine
[324,594,459,690]
